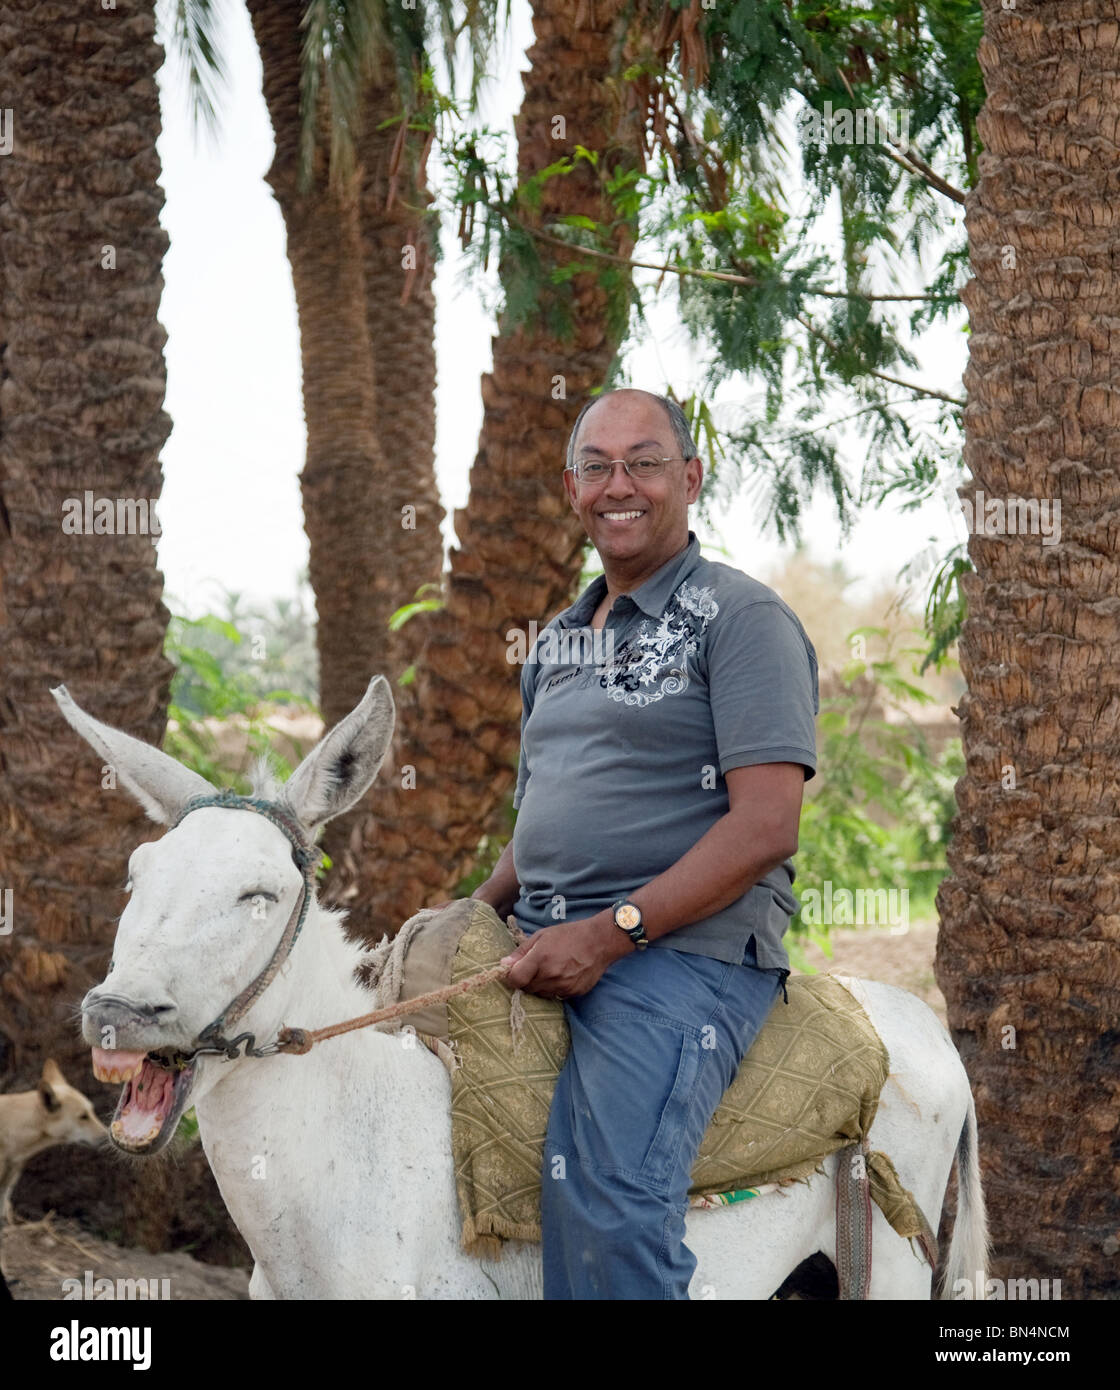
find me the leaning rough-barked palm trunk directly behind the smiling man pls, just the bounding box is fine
[339,0,643,935]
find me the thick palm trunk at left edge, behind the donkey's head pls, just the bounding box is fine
[0,0,172,1084]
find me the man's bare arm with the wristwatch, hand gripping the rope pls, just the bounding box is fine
[499,763,805,998]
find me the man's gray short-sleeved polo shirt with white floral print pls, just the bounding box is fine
[513,531,820,970]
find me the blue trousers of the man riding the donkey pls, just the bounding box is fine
[541,937,785,1300]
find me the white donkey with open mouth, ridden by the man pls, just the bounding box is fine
[54,677,987,1298]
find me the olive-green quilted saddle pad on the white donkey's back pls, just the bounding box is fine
[363,898,932,1255]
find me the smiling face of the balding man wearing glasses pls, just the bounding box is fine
[564,391,702,566]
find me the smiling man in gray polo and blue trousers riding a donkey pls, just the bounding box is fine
[475,389,818,1298]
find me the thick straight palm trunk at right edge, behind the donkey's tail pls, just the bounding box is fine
[937,0,1120,1298]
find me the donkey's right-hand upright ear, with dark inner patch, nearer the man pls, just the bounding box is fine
[283,676,396,830]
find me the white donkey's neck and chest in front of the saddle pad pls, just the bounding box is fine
[197,922,484,1298]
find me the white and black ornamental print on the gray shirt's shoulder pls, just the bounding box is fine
[599,581,720,708]
